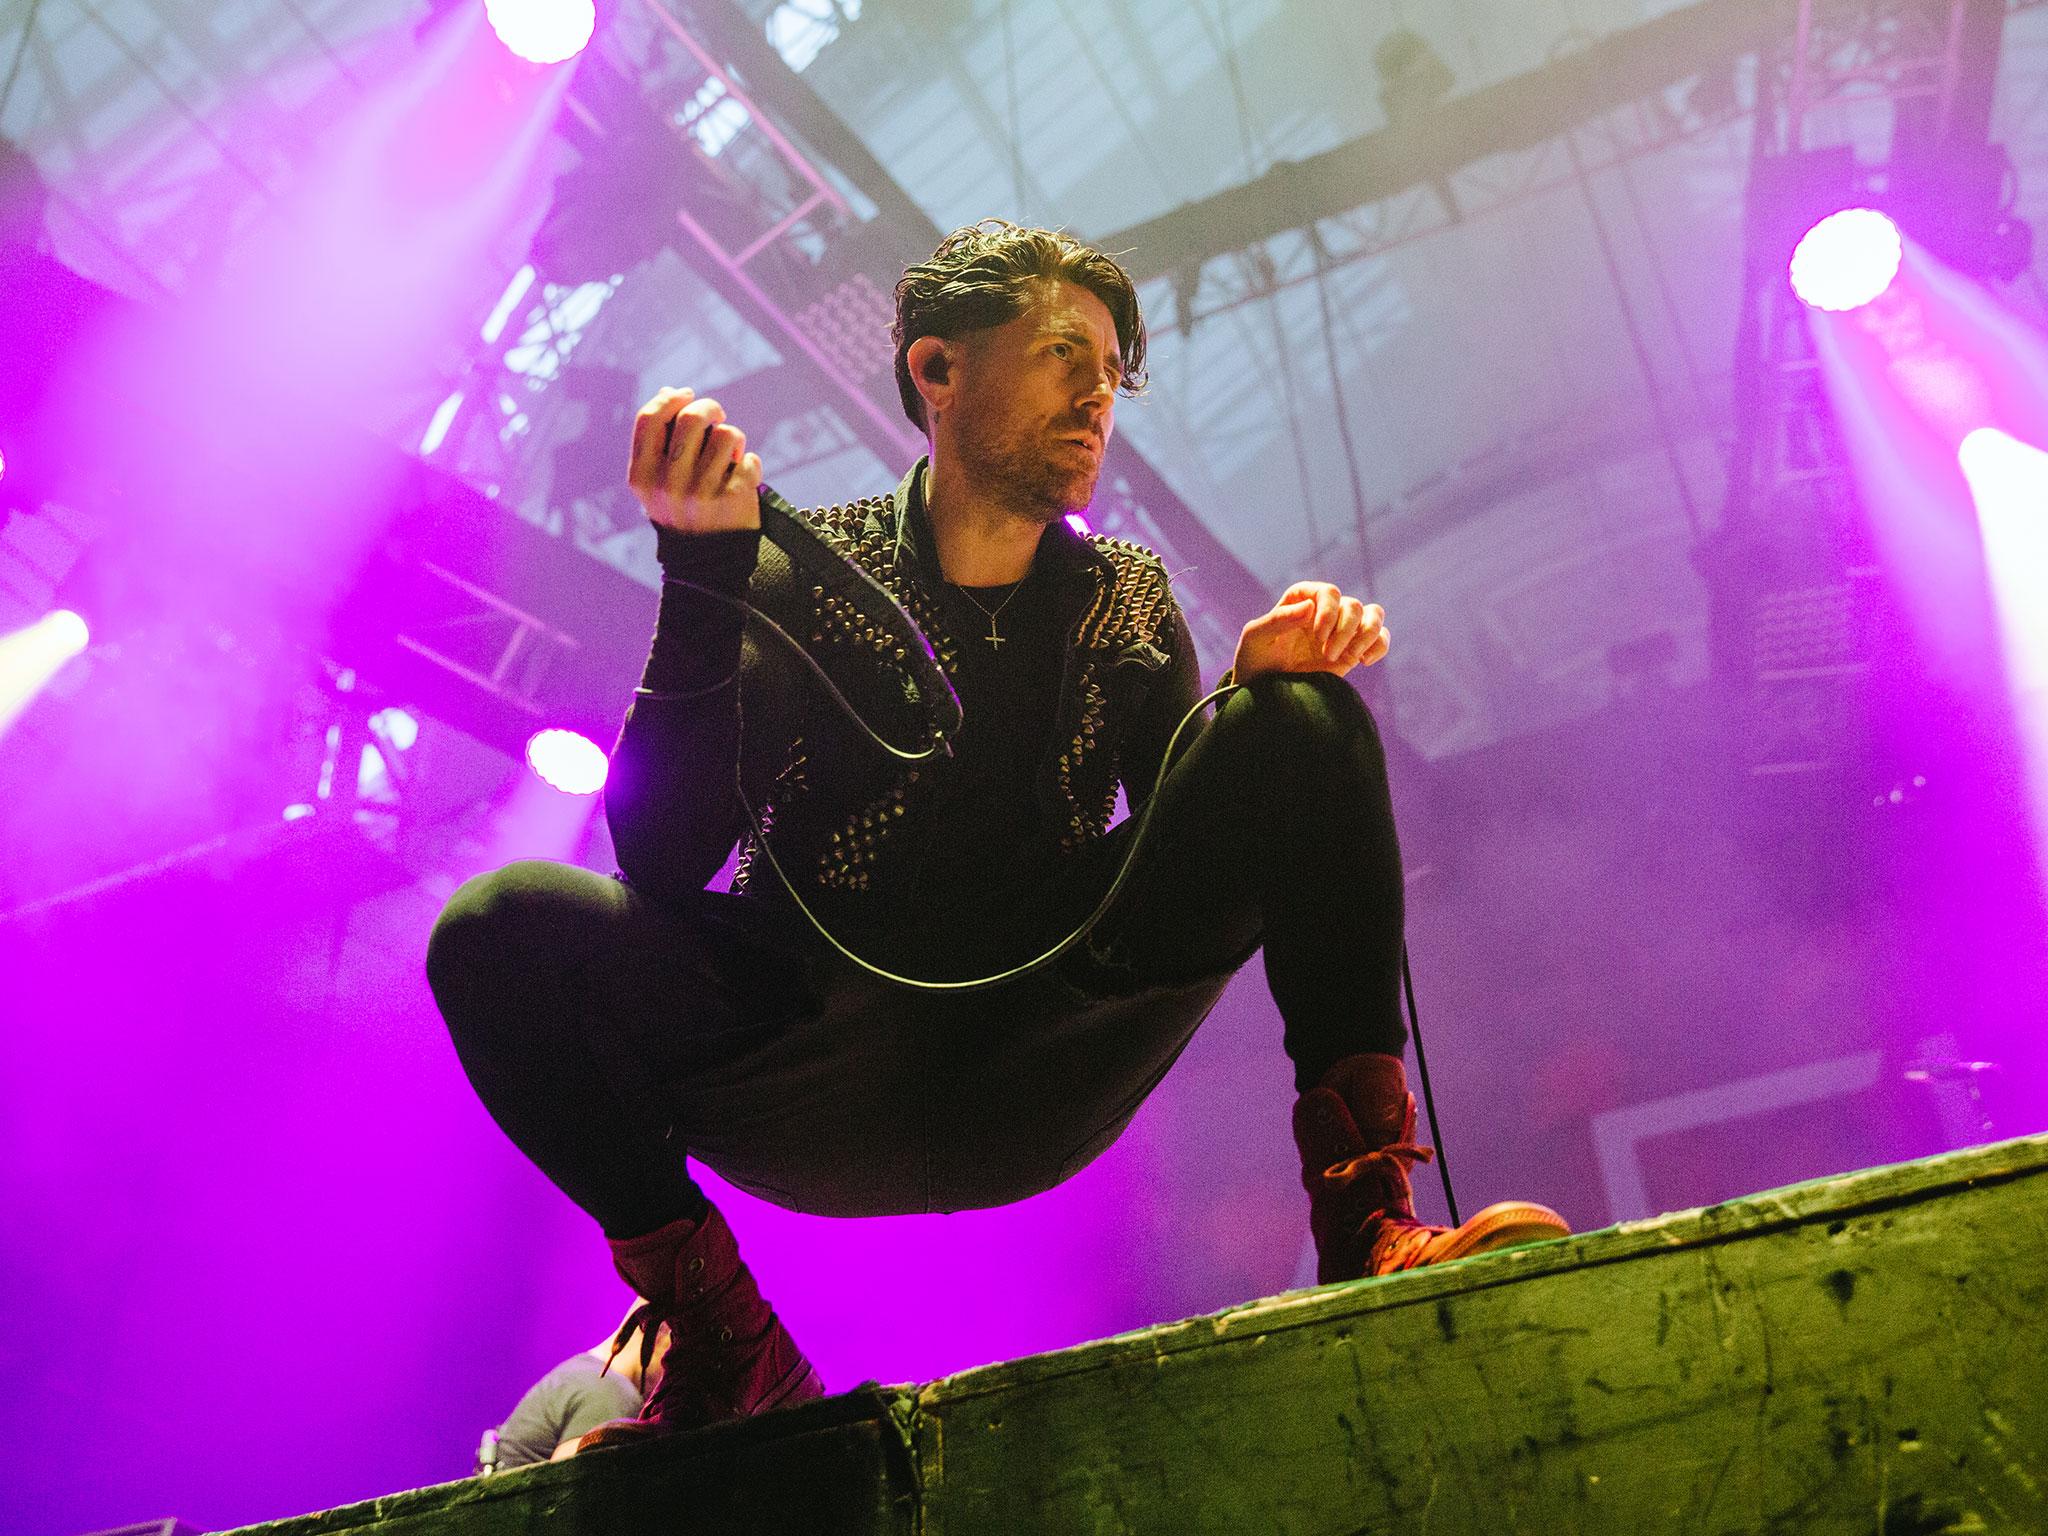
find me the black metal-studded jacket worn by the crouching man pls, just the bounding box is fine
[604,461,1200,962]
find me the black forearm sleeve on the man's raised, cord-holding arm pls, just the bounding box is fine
[604,528,762,901]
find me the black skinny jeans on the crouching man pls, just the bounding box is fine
[428,674,1407,1237]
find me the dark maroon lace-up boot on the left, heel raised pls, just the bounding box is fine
[575,1206,825,1452]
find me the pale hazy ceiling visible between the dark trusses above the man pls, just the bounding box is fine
[0,0,2048,756]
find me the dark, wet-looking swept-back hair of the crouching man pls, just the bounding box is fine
[889,219,1145,430]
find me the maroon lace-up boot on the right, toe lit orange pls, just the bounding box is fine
[1294,1055,1571,1284]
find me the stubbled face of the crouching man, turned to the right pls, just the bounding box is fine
[954,283,1122,522]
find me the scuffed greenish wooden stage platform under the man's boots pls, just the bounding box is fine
[228,1137,2048,1536]
